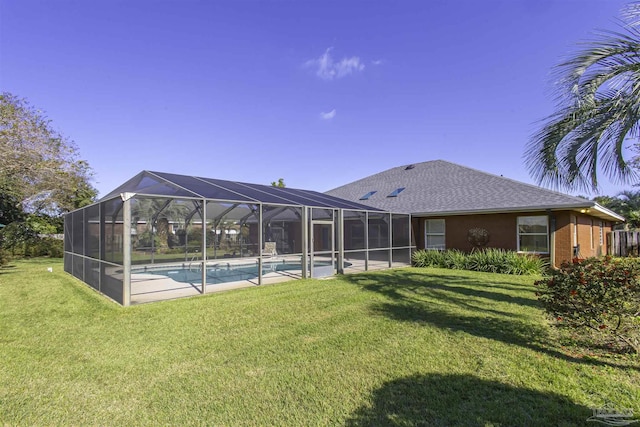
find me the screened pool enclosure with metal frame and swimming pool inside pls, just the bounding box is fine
[64,171,413,306]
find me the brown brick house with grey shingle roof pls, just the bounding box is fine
[327,160,624,266]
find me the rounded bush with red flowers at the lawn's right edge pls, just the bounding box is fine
[535,257,640,354]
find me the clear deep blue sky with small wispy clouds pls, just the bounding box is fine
[0,0,629,195]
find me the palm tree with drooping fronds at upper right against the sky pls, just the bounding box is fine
[525,4,640,191]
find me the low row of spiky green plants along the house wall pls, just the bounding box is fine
[412,248,548,275]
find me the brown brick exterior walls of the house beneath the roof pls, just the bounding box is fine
[412,211,612,266]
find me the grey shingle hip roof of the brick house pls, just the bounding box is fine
[327,160,622,220]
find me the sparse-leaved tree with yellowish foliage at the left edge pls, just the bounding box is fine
[0,92,97,215]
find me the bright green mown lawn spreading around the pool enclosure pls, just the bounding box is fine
[0,259,640,426]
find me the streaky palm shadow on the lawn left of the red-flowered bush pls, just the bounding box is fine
[345,270,640,370]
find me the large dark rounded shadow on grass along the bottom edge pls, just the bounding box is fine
[346,374,592,427]
